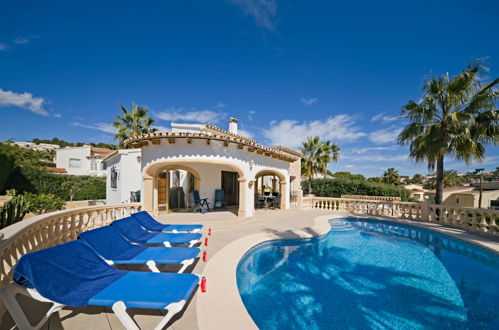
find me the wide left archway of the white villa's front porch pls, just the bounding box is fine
[143,159,253,217]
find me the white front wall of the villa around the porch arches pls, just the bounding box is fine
[142,139,289,216]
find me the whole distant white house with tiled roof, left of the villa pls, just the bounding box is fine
[56,145,113,176]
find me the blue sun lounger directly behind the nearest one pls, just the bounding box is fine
[78,226,200,273]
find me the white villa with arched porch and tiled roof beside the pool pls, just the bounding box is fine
[104,118,302,217]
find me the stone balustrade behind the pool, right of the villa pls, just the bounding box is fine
[302,197,499,236]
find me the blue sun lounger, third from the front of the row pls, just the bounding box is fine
[111,217,201,247]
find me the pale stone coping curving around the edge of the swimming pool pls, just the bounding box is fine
[196,212,499,330]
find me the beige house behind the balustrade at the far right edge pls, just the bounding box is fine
[425,186,499,208]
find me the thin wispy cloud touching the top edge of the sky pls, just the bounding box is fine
[230,0,277,30]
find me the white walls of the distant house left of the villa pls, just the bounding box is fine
[56,147,106,176]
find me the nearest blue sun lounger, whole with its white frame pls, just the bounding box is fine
[0,240,199,330]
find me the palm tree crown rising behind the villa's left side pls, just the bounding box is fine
[113,103,156,147]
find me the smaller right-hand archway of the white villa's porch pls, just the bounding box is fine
[254,169,289,209]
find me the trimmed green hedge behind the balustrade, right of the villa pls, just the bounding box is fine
[302,179,411,201]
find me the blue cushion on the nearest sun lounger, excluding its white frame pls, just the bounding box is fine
[14,240,199,308]
